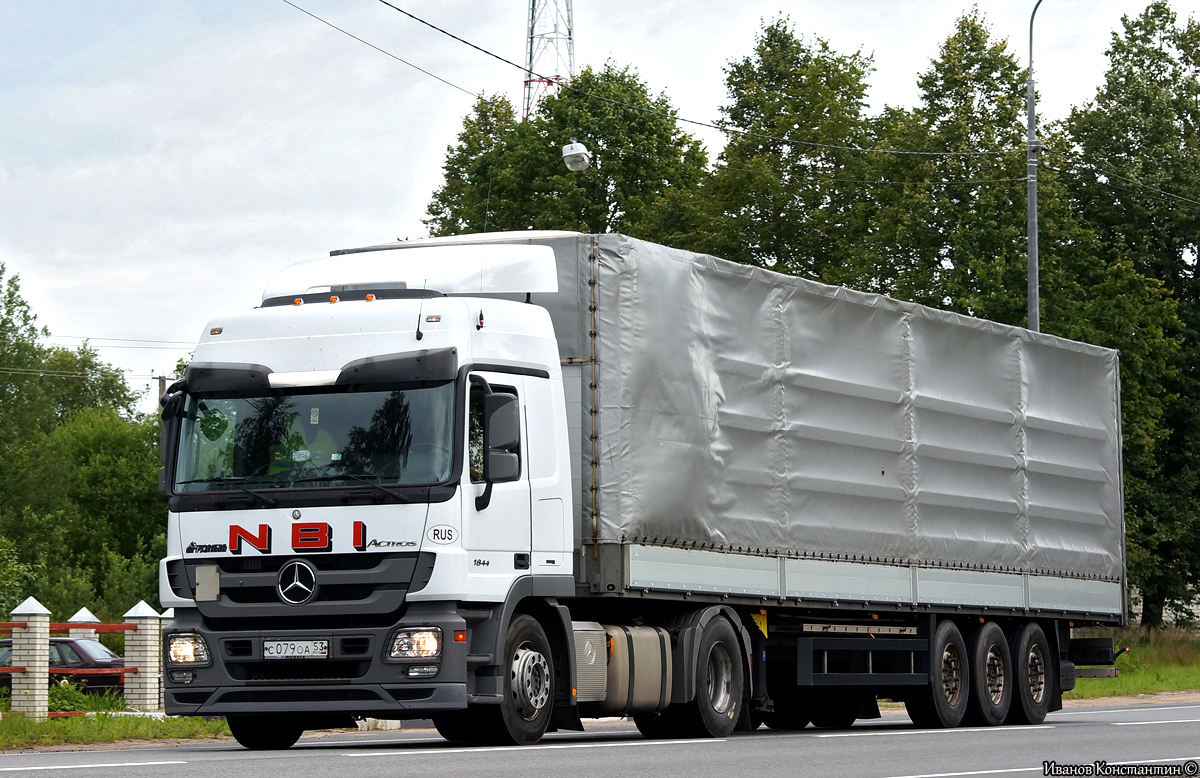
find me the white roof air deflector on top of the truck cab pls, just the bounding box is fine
[263,244,558,301]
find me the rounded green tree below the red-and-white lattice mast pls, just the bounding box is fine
[425,64,707,237]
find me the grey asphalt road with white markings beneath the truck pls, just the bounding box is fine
[0,704,1200,778]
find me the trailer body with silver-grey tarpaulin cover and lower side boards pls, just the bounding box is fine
[336,233,1124,616]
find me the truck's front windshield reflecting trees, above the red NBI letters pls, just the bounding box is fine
[175,382,455,492]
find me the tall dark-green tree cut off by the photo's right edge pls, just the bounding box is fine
[1050,0,1200,627]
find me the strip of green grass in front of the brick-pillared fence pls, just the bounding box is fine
[0,713,229,749]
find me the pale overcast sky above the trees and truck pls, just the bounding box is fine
[0,0,1180,409]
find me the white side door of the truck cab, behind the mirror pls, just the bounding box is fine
[463,372,530,576]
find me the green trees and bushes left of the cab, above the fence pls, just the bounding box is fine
[0,261,166,621]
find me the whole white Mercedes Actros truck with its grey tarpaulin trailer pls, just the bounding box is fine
[161,232,1126,748]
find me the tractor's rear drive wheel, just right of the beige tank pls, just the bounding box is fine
[680,617,745,737]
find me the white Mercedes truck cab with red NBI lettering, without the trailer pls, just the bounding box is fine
[160,245,575,743]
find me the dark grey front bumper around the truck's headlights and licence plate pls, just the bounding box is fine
[163,603,467,718]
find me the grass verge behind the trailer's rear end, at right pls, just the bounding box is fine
[1062,628,1200,700]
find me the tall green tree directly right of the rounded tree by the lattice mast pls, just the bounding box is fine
[683,19,871,283]
